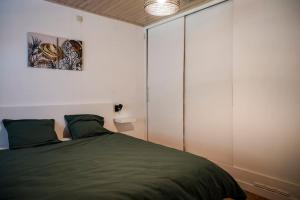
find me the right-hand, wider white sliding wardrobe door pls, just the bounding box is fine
[185,1,233,164]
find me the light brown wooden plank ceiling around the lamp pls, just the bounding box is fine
[46,0,211,26]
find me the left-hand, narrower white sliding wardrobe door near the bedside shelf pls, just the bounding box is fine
[148,18,184,149]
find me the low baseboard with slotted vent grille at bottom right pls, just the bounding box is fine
[215,162,300,200]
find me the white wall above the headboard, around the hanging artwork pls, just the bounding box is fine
[0,0,145,141]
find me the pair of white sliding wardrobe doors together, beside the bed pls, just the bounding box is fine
[147,1,233,163]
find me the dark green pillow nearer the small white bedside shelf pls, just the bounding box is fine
[65,114,111,139]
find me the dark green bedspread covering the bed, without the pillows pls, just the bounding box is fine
[0,134,245,200]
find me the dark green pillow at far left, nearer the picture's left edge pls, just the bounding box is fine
[2,119,60,149]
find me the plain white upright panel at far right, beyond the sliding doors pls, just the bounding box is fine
[233,0,300,196]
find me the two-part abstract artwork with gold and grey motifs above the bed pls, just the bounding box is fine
[27,33,82,71]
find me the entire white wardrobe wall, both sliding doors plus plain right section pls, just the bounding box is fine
[147,0,300,195]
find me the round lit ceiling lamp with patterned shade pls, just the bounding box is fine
[144,0,180,16]
